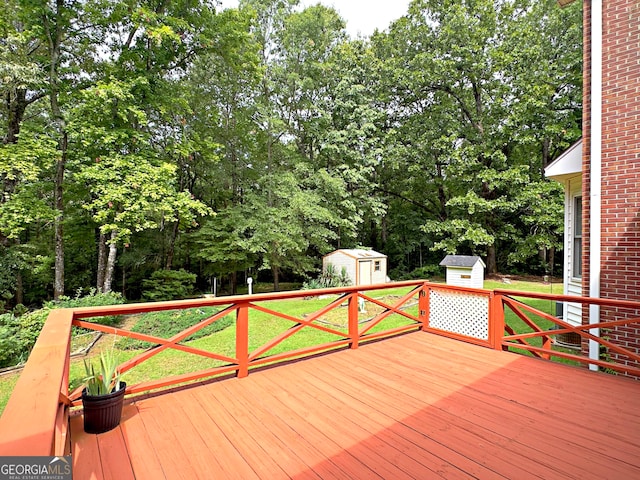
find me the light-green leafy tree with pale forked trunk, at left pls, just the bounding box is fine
[70,79,209,292]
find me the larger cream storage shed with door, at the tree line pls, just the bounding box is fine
[322,248,387,285]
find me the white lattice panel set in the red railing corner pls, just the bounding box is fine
[429,290,489,340]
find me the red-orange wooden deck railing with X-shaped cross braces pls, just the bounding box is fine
[0,281,640,455]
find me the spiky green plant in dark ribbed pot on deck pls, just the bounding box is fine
[82,352,127,433]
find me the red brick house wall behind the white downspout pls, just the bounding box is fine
[583,0,640,376]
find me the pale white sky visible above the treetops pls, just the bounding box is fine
[221,0,410,38]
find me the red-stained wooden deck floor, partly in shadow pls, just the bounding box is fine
[71,332,640,480]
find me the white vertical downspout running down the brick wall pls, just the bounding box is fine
[589,0,602,370]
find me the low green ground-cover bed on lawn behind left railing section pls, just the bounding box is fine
[116,307,234,350]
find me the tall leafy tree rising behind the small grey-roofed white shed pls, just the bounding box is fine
[376,0,580,273]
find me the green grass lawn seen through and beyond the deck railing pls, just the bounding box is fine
[0,281,562,412]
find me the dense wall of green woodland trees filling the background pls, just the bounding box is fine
[0,0,582,304]
